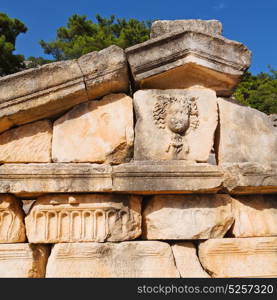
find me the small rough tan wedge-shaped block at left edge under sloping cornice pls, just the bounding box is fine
[0,121,52,163]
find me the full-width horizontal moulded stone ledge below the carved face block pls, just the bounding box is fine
[0,161,272,197]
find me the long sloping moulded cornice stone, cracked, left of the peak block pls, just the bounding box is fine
[0,45,129,132]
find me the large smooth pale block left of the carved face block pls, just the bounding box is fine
[52,94,134,164]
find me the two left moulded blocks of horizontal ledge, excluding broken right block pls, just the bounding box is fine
[0,161,223,195]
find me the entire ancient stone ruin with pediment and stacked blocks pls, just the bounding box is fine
[0,20,277,277]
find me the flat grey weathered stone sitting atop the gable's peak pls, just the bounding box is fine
[150,19,222,39]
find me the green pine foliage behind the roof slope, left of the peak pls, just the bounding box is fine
[40,14,151,60]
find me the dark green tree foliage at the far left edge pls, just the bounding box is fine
[0,12,27,76]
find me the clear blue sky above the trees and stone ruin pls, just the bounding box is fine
[0,0,277,74]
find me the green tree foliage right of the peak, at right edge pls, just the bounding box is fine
[234,67,277,114]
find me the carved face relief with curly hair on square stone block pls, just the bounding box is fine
[153,96,199,156]
